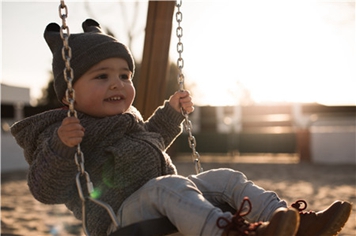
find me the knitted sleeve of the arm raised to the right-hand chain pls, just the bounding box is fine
[145,101,184,149]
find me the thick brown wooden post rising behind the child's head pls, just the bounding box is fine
[135,1,175,119]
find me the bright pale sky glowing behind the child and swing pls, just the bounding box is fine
[1,0,356,105]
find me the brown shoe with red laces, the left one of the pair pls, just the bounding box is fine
[216,198,299,236]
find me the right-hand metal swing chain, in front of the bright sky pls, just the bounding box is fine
[176,0,203,174]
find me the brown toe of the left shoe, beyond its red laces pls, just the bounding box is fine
[264,209,299,236]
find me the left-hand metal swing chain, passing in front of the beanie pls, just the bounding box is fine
[59,0,119,235]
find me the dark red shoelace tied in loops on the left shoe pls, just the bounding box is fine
[216,197,262,236]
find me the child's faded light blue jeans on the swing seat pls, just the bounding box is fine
[109,169,287,235]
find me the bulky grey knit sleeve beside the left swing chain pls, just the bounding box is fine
[28,129,78,204]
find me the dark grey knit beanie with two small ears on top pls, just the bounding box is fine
[44,19,135,102]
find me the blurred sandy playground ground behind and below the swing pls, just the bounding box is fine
[1,155,356,236]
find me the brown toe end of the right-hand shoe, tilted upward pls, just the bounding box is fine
[318,201,352,236]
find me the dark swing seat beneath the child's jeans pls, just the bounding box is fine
[109,204,236,236]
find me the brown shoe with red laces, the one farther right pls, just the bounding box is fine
[292,200,352,236]
